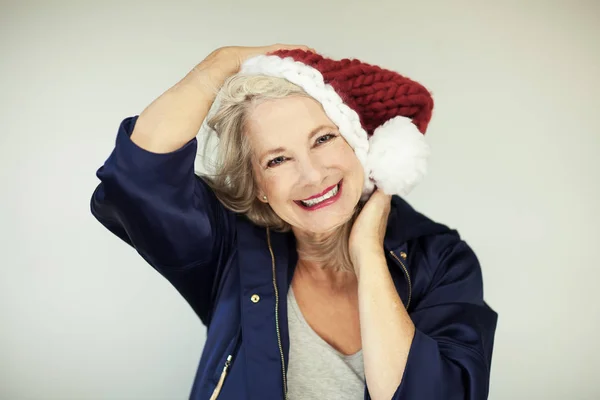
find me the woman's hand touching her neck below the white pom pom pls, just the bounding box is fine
[348,189,392,271]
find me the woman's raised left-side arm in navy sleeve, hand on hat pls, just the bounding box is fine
[90,45,314,325]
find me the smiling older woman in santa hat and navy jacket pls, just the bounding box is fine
[91,45,497,400]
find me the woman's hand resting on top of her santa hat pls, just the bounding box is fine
[194,43,315,78]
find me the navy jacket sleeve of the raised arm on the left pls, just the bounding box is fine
[90,116,235,324]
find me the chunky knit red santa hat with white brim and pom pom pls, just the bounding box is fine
[197,50,433,196]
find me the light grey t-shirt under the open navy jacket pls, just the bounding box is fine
[287,287,365,400]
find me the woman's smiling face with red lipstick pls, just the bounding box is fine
[247,96,364,233]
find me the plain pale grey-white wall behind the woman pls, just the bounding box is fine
[0,0,600,400]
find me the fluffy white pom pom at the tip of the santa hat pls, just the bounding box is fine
[367,116,430,196]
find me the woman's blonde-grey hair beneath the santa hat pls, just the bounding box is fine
[201,75,358,271]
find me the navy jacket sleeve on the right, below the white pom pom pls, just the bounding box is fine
[393,235,497,400]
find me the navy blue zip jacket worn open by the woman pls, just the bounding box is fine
[91,116,497,400]
